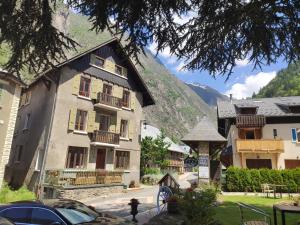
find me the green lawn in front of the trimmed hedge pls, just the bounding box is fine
[216,196,300,225]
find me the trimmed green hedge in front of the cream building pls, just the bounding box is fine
[224,167,300,192]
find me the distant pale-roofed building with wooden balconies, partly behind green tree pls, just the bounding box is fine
[141,123,189,173]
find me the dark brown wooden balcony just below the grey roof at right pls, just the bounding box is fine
[236,115,266,128]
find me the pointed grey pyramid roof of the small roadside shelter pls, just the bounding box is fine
[181,116,226,143]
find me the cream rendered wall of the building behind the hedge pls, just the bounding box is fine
[228,123,300,169]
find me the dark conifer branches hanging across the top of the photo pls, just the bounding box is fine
[0,0,300,76]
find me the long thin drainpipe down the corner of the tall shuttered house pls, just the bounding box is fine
[38,71,59,200]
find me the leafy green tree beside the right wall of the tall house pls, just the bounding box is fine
[141,131,170,171]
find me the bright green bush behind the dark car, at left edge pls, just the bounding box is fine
[0,184,36,203]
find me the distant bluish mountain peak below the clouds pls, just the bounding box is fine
[186,83,229,107]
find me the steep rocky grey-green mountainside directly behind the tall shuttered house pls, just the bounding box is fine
[0,6,216,141]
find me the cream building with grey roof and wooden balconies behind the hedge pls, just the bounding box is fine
[218,96,300,169]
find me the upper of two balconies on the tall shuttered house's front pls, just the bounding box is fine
[95,92,122,111]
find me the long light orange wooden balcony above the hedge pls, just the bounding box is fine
[236,139,284,153]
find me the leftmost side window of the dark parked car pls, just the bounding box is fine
[0,207,31,223]
